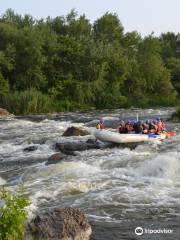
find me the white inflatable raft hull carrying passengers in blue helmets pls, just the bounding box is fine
[94,129,166,143]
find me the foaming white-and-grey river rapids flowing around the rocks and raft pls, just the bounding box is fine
[0,108,180,240]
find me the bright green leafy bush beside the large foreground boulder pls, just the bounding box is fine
[0,188,29,240]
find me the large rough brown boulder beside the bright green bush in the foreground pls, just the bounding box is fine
[25,208,92,240]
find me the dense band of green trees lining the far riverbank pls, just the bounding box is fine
[0,10,180,114]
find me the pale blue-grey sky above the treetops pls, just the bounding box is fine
[0,0,180,36]
